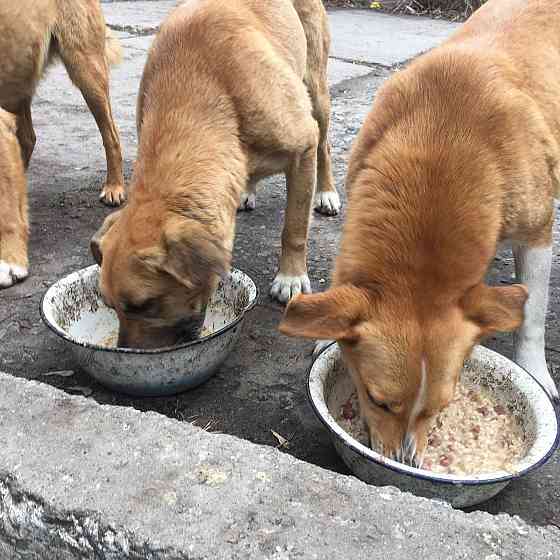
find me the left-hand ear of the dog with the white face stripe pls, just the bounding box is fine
[278,285,371,342]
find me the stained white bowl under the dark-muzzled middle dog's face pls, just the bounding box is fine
[41,265,257,396]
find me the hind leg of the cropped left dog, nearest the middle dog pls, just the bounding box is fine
[57,33,126,206]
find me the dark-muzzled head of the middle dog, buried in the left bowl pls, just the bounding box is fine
[90,205,230,348]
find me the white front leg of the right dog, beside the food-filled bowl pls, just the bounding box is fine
[513,246,558,399]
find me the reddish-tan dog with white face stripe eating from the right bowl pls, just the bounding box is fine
[280,0,560,465]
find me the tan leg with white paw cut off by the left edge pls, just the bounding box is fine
[0,109,29,289]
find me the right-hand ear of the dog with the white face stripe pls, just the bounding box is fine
[461,284,529,336]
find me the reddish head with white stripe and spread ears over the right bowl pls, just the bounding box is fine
[280,284,528,466]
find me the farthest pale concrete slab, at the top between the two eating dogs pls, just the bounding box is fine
[329,10,458,66]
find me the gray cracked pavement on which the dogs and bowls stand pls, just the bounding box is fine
[0,1,560,560]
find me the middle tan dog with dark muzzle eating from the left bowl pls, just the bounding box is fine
[92,0,339,348]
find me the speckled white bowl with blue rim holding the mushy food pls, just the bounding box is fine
[308,344,558,507]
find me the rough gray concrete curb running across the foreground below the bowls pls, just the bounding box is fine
[0,374,560,560]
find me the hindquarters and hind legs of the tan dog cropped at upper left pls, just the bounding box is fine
[0,0,125,206]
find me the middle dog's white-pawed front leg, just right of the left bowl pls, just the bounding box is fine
[270,144,317,303]
